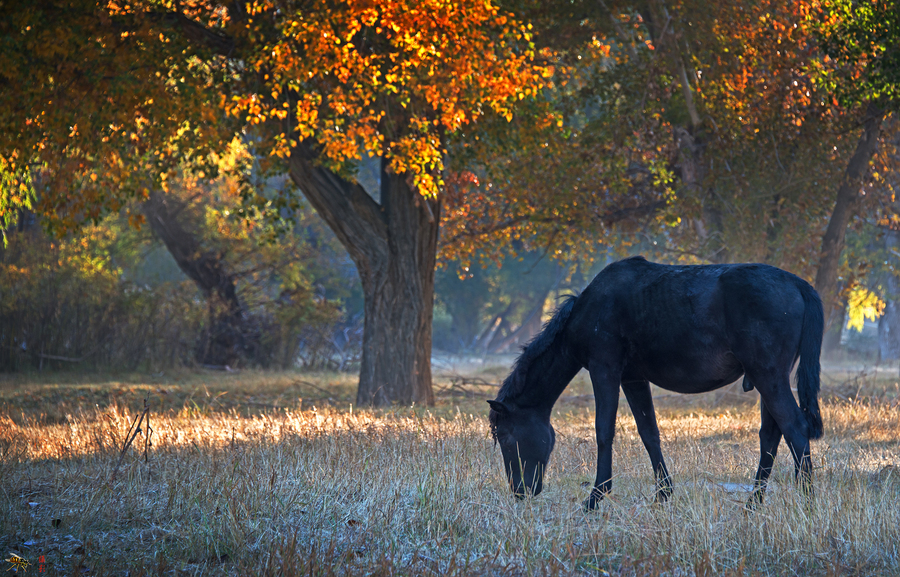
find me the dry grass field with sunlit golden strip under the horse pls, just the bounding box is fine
[0,361,900,576]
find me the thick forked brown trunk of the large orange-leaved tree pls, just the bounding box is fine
[289,143,440,406]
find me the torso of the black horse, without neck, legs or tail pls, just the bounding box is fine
[570,258,805,393]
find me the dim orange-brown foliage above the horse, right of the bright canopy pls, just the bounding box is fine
[442,0,857,277]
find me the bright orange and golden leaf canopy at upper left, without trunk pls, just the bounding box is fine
[0,0,553,237]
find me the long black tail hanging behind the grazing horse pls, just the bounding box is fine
[797,281,825,439]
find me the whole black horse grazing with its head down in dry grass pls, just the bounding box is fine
[488,257,824,509]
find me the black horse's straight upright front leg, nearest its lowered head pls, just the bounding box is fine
[584,367,619,511]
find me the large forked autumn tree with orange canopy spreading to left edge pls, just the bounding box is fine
[0,0,549,405]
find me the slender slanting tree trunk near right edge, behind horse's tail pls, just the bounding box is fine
[816,102,885,327]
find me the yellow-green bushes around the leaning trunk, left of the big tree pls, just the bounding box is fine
[0,169,359,371]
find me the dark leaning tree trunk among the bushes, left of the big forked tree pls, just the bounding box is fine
[142,192,251,366]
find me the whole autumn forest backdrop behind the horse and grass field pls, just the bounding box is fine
[0,0,900,405]
